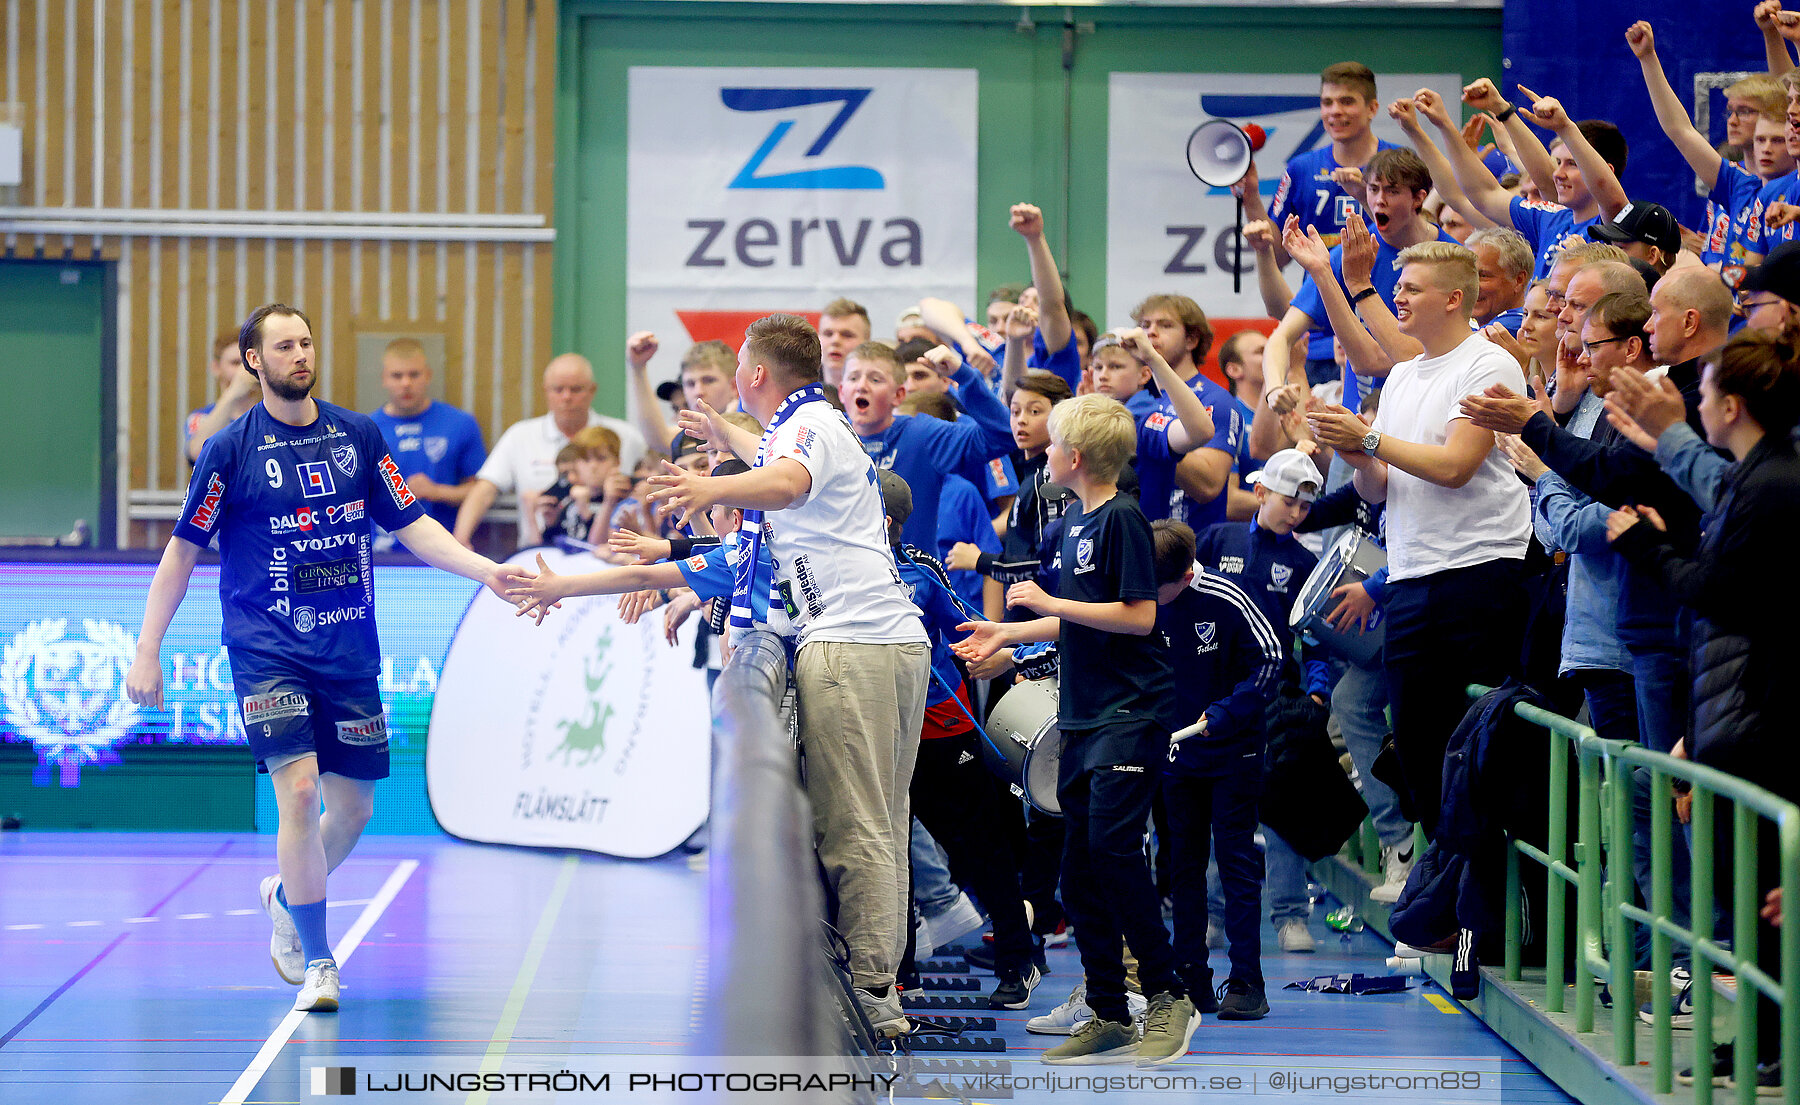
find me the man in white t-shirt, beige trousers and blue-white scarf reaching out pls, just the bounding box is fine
[650,315,931,1035]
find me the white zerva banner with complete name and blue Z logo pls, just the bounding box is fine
[626,67,979,385]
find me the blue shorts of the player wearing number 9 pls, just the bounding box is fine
[230,648,387,779]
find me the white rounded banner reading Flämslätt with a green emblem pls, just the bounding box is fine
[425,549,713,858]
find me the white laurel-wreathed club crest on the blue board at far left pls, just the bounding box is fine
[0,617,139,786]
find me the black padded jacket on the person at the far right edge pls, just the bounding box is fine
[1613,434,1800,799]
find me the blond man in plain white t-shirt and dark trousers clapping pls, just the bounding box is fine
[1307,241,1532,835]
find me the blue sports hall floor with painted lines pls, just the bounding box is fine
[0,833,1570,1105]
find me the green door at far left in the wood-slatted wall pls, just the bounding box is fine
[0,261,113,545]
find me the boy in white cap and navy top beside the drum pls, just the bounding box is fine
[1195,448,1332,952]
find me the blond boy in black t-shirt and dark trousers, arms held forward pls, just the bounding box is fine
[956,396,1201,1065]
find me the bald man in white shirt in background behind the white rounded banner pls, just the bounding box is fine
[455,353,644,549]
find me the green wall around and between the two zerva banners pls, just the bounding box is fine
[554,0,1501,409]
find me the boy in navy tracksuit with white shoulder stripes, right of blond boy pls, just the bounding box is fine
[1152,520,1283,1020]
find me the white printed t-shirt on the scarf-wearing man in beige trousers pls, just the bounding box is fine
[763,403,927,644]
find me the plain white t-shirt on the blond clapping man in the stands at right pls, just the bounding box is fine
[1375,335,1532,581]
